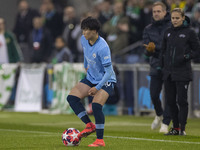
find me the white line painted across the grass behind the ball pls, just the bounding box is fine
[0,129,200,145]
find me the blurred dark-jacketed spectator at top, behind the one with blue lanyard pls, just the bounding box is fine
[40,0,63,40]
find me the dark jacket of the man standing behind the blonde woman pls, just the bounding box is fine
[143,13,171,75]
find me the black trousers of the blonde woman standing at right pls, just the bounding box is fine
[164,77,189,131]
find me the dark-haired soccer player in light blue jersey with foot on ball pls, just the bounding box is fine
[67,17,116,147]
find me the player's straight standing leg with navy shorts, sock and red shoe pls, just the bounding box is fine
[88,83,114,147]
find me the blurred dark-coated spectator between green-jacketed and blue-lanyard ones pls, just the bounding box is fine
[13,0,39,62]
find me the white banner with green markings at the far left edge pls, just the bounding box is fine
[0,64,18,110]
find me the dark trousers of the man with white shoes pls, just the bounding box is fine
[150,76,171,125]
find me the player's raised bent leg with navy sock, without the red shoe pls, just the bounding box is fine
[67,82,91,127]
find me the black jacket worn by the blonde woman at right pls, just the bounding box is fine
[160,17,200,81]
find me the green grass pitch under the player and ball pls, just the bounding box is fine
[0,112,200,150]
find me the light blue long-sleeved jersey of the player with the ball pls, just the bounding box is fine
[81,36,116,90]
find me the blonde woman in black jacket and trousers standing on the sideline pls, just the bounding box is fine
[160,8,200,135]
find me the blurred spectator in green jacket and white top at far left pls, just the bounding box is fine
[0,17,22,64]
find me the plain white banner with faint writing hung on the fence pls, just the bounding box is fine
[15,64,46,112]
